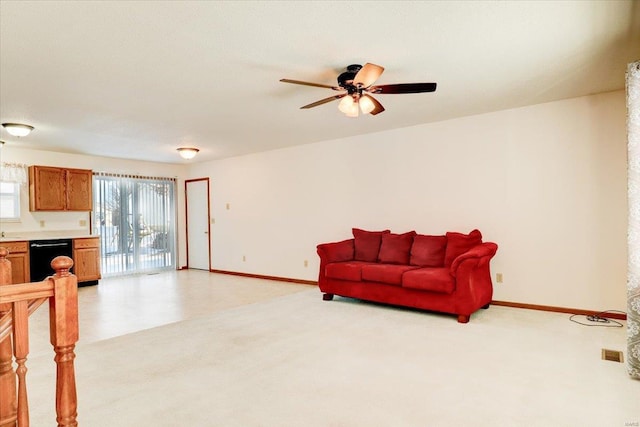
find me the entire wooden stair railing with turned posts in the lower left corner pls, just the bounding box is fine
[0,247,78,427]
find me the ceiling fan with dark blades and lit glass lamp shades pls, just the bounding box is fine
[280,63,436,117]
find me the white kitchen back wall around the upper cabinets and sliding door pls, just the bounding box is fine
[0,148,187,266]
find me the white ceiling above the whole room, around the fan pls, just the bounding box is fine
[0,0,640,163]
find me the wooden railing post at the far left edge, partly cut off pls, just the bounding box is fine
[0,247,18,427]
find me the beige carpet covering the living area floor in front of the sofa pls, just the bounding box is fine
[29,288,640,427]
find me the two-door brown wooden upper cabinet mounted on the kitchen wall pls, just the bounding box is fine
[29,166,93,211]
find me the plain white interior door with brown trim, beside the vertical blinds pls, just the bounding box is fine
[185,178,211,271]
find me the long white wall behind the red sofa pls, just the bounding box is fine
[189,91,627,310]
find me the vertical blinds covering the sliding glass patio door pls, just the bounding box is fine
[92,172,176,277]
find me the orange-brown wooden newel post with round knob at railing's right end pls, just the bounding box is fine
[49,256,78,427]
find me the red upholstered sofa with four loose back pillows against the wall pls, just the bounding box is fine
[317,228,498,323]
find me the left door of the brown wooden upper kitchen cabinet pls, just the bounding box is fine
[29,166,67,211]
